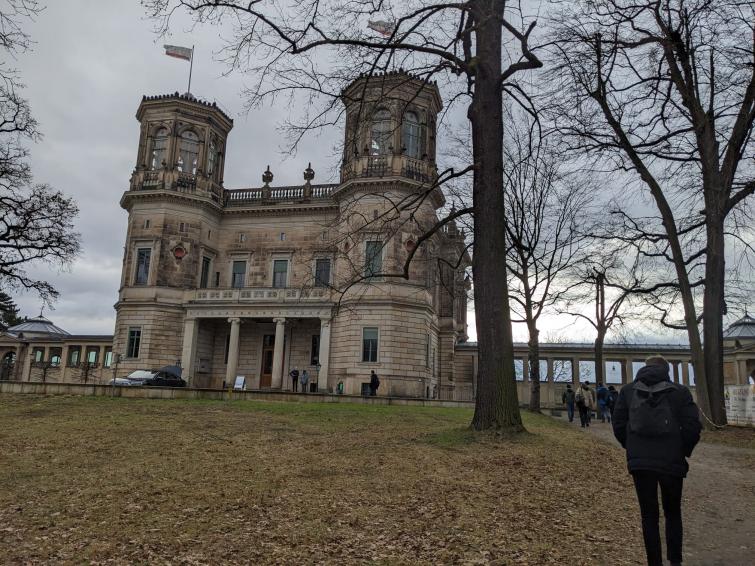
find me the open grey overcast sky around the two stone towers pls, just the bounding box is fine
[8,0,704,341]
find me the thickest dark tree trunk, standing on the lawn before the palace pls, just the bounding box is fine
[468,0,523,431]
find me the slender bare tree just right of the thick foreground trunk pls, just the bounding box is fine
[504,108,591,412]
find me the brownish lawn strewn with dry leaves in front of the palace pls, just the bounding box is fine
[0,396,644,565]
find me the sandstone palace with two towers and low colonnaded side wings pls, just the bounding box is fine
[0,72,755,405]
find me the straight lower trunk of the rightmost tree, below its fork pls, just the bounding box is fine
[695,212,727,426]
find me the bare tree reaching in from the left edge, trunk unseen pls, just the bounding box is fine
[0,0,79,301]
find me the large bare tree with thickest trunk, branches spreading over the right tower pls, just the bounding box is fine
[144,0,541,430]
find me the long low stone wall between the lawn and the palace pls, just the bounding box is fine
[0,381,474,408]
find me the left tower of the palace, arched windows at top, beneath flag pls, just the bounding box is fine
[114,93,233,370]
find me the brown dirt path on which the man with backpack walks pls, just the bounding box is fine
[552,412,755,566]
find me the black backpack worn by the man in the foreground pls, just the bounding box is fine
[629,381,679,436]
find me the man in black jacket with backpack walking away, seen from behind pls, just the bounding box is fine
[613,356,701,566]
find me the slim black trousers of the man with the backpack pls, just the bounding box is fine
[632,470,684,566]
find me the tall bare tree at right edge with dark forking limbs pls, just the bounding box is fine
[550,0,755,425]
